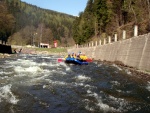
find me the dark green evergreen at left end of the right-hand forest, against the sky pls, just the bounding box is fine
[73,0,94,44]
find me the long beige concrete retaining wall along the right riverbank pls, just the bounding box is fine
[68,33,150,71]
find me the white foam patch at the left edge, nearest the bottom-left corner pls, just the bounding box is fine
[0,84,19,104]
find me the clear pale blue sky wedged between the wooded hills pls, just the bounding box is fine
[21,0,88,16]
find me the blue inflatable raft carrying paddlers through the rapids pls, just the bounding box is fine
[65,58,88,65]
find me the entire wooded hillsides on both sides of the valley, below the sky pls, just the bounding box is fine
[0,0,150,47]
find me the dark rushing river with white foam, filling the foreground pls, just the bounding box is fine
[0,54,150,113]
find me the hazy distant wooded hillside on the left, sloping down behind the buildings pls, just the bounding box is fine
[0,0,75,46]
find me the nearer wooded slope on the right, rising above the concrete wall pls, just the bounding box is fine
[73,0,150,44]
